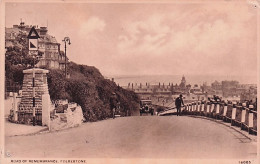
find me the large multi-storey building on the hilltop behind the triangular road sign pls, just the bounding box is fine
[5,22,68,69]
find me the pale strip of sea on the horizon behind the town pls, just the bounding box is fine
[106,75,257,86]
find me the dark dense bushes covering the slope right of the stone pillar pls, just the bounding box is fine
[48,62,139,121]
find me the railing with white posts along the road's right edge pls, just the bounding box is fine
[164,101,257,135]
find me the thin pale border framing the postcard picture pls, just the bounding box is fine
[0,0,260,164]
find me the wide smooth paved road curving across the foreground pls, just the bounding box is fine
[6,116,257,159]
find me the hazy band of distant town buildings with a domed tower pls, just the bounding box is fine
[124,76,257,101]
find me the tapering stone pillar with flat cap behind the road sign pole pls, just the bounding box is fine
[18,68,49,124]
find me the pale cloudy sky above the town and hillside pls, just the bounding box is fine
[5,0,257,77]
